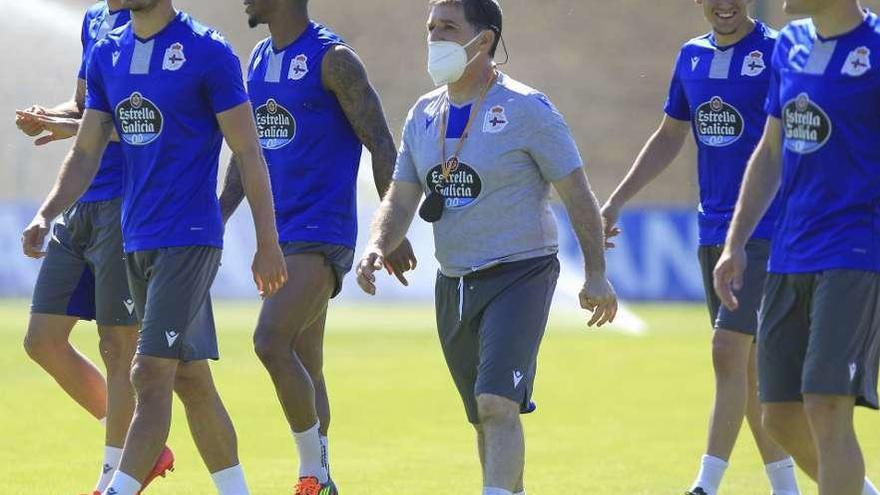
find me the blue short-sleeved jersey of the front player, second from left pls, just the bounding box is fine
[86,12,247,252]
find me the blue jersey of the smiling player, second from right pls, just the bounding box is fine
[665,22,778,246]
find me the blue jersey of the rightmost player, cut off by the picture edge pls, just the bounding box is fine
[767,12,880,273]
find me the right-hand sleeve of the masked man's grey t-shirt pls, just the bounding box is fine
[526,95,584,182]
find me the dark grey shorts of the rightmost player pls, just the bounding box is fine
[758,270,880,409]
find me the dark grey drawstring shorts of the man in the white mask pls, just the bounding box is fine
[435,255,559,424]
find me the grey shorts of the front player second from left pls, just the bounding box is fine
[126,246,222,361]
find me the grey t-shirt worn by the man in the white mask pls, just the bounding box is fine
[394,74,583,277]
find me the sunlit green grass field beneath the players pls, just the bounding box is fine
[0,301,880,495]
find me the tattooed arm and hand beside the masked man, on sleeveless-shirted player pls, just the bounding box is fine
[321,45,416,285]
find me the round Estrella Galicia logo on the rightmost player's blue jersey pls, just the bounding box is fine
[782,93,832,155]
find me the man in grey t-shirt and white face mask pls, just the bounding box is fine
[357,0,617,495]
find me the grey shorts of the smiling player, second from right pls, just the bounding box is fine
[698,239,770,336]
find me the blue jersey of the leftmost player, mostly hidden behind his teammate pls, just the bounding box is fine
[79,1,131,203]
